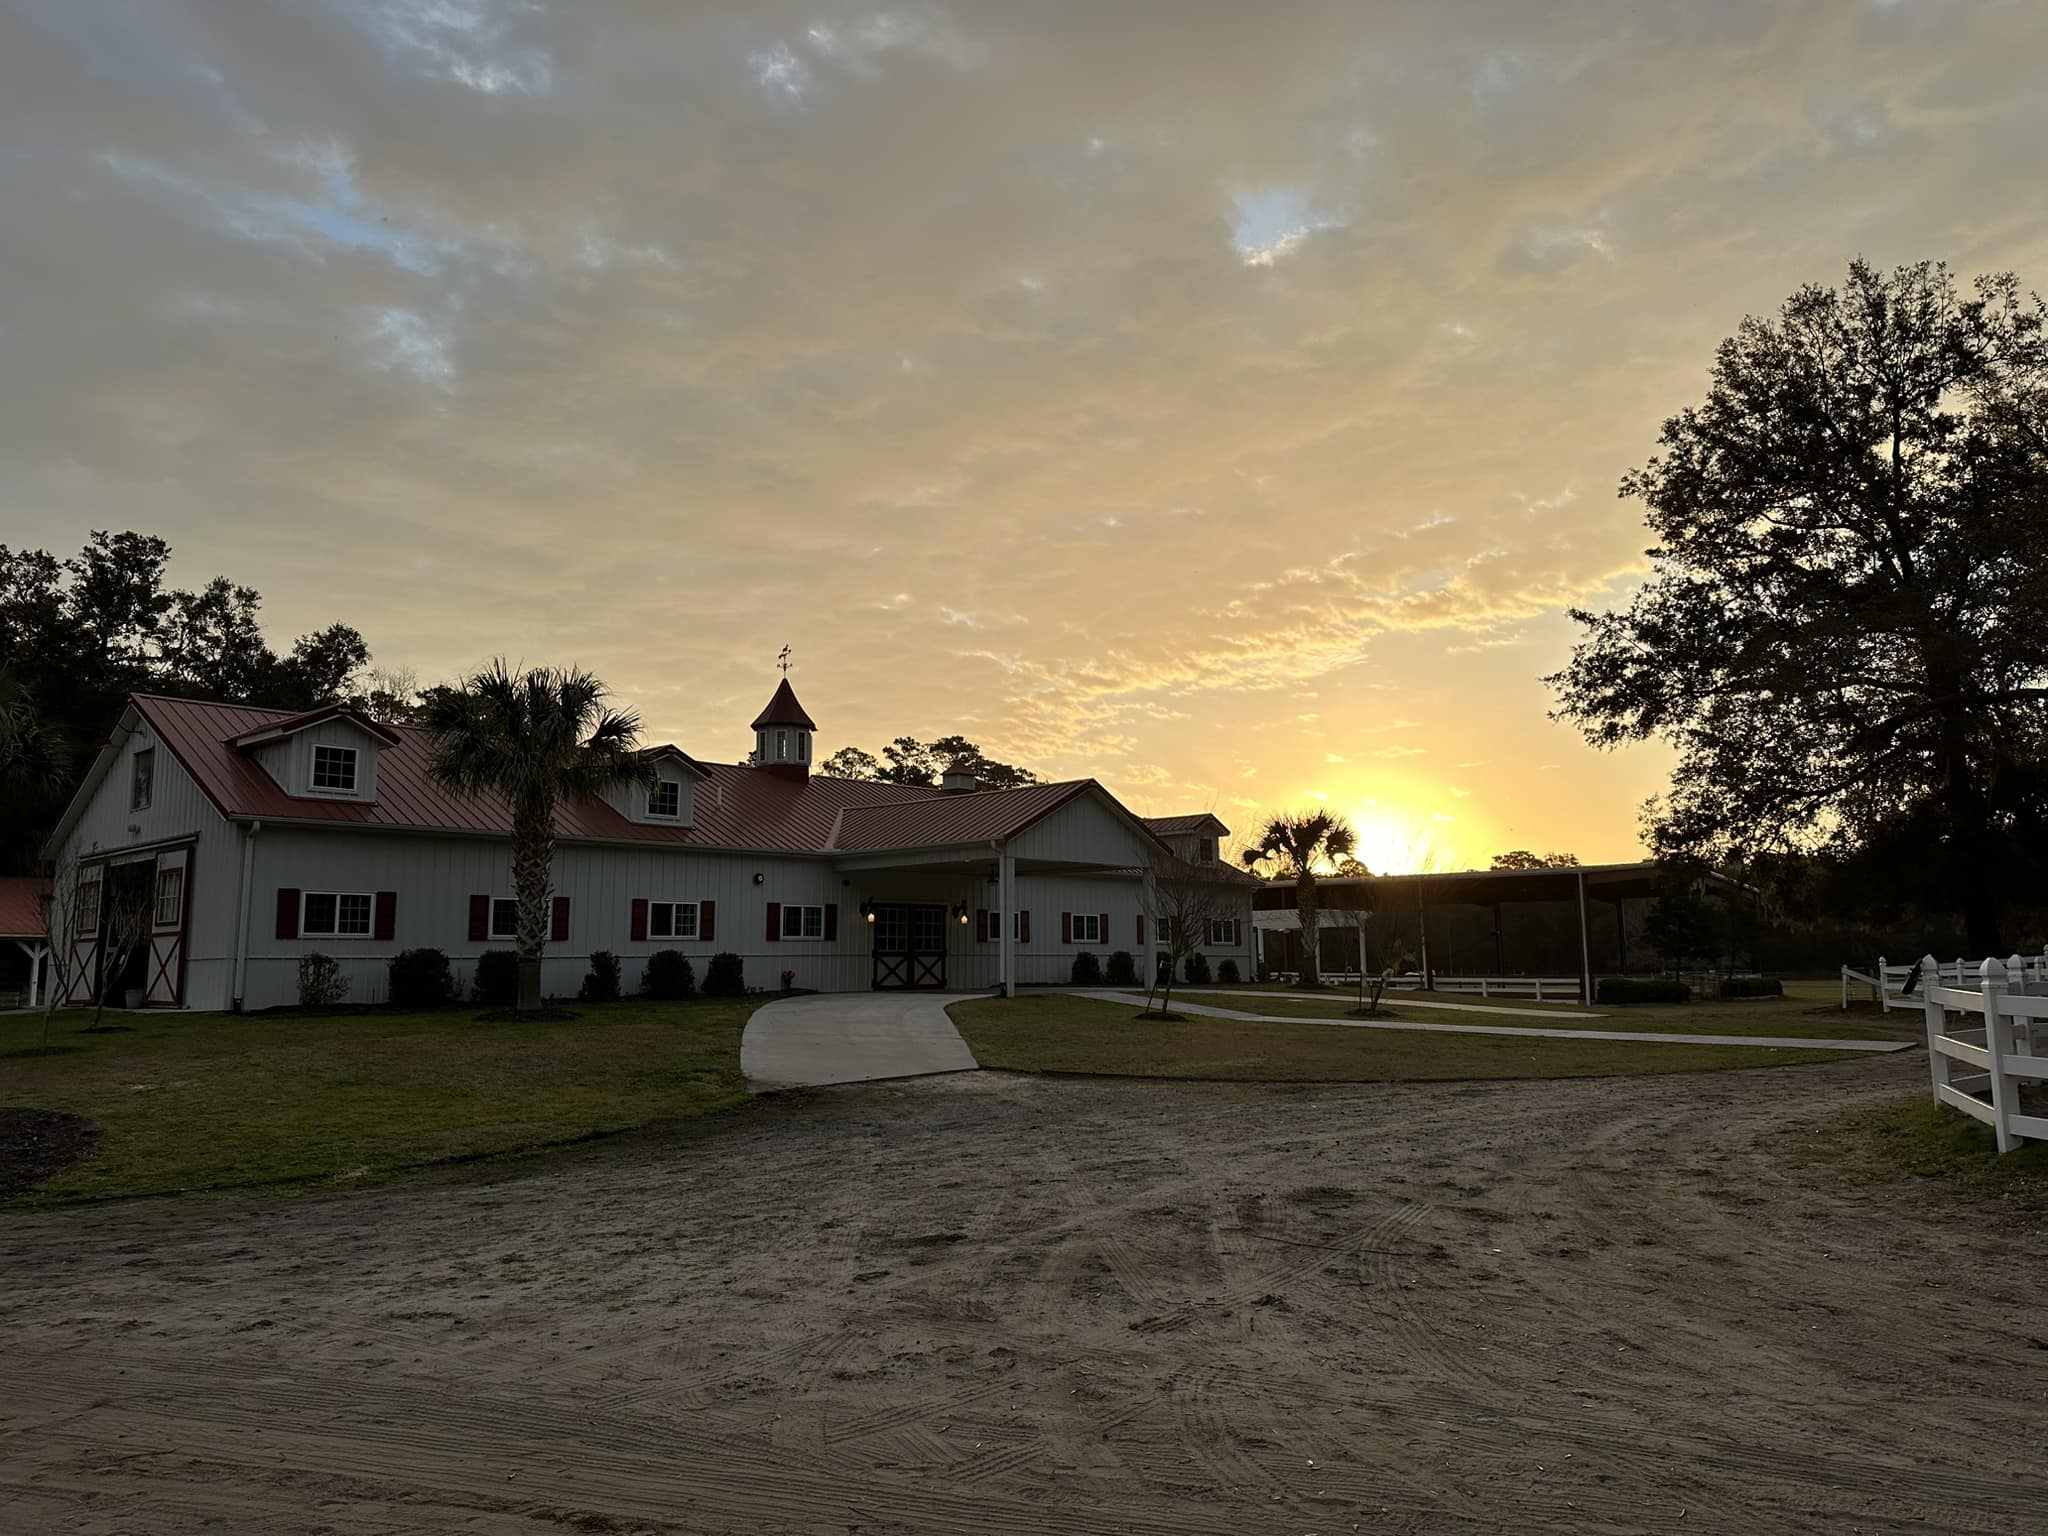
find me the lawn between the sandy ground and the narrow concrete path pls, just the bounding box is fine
[948,993,1875,1083]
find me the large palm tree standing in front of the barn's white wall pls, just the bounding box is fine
[420,662,649,1014]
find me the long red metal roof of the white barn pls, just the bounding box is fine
[133,694,1171,868]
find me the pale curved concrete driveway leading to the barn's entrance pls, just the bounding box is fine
[739,991,981,1094]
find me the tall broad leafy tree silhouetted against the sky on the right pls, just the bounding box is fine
[1548,262,2048,954]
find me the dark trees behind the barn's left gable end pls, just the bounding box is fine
[0,532,387,874]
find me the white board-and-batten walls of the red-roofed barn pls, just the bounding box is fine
[48,713,1253,1010]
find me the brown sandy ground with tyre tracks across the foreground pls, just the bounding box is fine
[0,1057,2048,1536]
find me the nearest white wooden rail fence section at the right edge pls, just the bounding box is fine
[1921,954,2048,1153]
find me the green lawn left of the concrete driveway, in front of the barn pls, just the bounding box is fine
[0,1001,758,1204]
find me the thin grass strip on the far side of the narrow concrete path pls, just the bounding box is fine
[1130,987,1923,1040]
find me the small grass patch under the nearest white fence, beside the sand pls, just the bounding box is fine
[1800,1094,2048,1217]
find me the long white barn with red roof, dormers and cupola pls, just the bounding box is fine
[45,678,1257,1010]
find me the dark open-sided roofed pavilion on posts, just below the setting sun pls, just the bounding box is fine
[1251,860,1737,1001]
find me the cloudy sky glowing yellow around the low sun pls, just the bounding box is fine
[0,0,2048,866]
